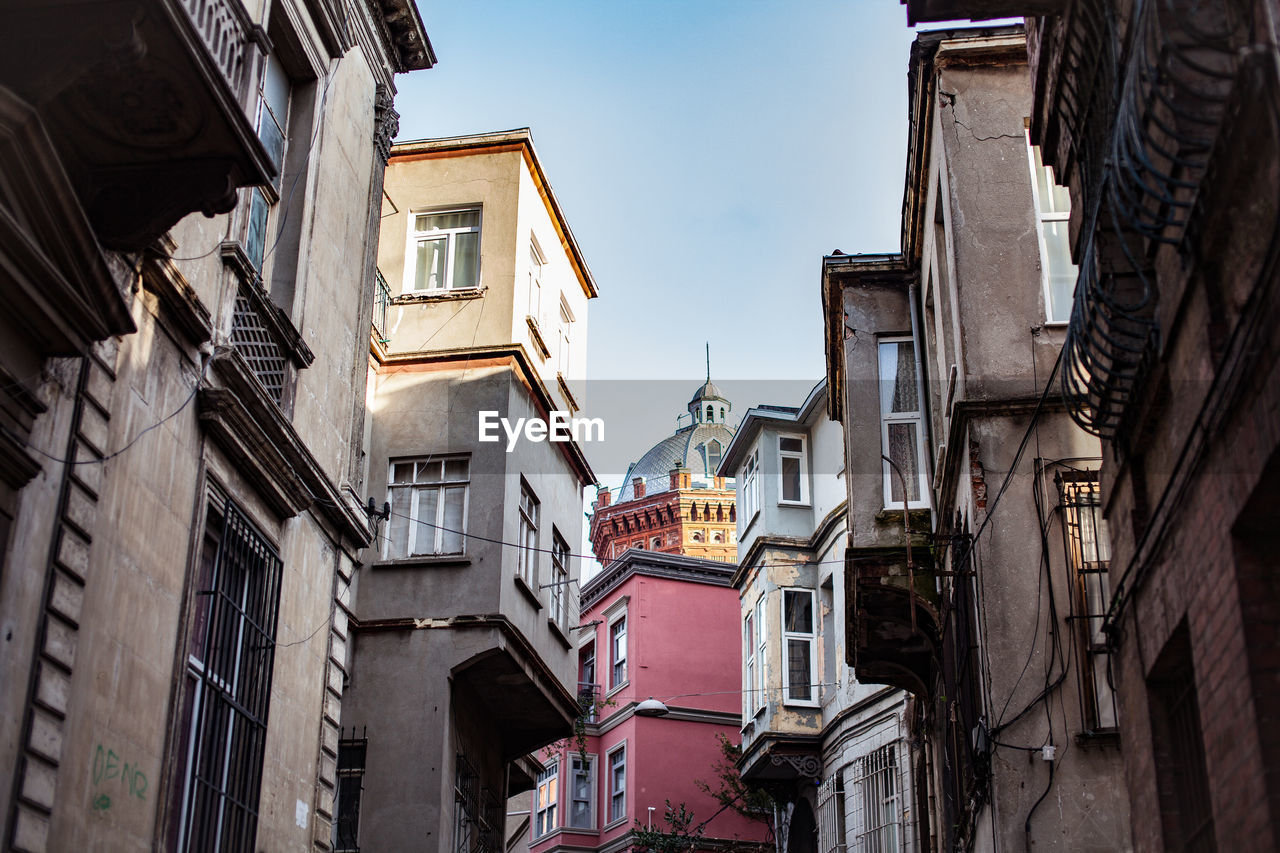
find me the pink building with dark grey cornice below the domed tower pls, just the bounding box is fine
[530,551,765,853]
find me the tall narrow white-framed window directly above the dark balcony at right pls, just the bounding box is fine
[879,338,929,508]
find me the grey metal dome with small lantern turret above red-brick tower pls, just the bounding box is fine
[616,379,735,503]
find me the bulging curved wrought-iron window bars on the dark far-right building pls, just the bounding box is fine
[1059,0,1247,438]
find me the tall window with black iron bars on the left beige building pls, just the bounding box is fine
[174,497,283,853]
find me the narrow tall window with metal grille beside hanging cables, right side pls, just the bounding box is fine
[1059,471,1117,731]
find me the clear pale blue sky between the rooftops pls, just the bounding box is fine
[396,0,936,389]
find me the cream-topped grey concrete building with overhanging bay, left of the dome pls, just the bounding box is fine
[340,131,596,853]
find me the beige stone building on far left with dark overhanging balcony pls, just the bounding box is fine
[0,0,434,850]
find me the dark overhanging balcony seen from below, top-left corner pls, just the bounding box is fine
[0,0,275,250]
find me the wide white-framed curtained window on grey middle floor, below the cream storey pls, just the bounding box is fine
[383,456,468,560]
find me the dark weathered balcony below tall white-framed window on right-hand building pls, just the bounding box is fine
[845,545,941,695]
